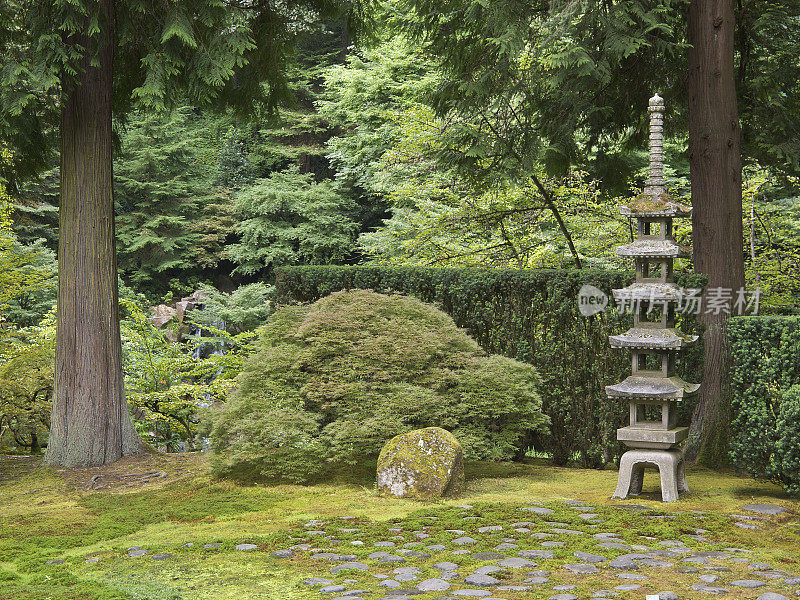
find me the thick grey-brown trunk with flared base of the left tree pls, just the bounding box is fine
[45,0,142,467]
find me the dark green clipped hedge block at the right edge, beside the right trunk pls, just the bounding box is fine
[728,317,800,494]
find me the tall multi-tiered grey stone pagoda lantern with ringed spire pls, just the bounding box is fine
[606,94,700,502]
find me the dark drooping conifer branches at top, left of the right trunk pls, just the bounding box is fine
[398,0,684,181]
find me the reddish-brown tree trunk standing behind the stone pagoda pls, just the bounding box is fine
[688,0,744,467]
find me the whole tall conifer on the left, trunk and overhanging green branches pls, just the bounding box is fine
[0,0,360,466]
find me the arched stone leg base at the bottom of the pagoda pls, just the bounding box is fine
[613,449,689,502]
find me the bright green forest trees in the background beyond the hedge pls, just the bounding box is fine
[6,12,800,318]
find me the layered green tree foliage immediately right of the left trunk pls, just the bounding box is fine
[114,107,233,293]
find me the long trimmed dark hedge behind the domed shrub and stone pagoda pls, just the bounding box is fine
[275,266,702,467]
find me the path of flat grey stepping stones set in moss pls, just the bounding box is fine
[101,501,800,600]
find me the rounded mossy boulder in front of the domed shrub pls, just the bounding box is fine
[378,427,464,500]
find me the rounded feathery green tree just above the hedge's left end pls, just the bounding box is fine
[228,168,356,274]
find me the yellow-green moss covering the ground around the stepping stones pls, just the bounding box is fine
[0,454,800,600]
